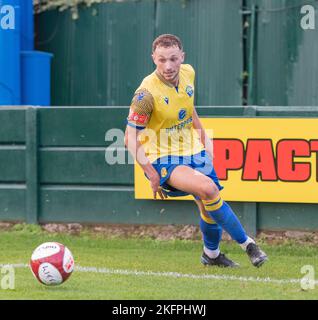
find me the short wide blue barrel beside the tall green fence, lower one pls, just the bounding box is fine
[21,51,53,106]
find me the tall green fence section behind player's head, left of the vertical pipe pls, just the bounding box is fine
[36,0,243,106]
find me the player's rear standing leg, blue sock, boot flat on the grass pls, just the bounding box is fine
[195,200,238,267]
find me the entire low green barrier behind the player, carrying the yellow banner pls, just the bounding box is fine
[0,106,318,234]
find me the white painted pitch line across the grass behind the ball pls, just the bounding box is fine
[0,263,318,285]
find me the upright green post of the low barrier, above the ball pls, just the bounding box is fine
[25,107,39,224]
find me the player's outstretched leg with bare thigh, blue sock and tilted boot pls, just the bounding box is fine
[167,165,267,267]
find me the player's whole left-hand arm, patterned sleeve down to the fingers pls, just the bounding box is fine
[125,90,165,199]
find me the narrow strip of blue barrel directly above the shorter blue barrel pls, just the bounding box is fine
[20,0,34,51]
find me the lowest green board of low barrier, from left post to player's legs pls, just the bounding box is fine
[39,186,246,224]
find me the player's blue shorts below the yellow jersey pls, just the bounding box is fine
[152,150,224,199]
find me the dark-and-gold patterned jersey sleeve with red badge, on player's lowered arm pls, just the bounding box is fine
[127,89,154,130]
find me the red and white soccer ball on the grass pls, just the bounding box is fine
[30,242,74,286]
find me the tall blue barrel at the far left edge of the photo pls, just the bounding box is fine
[0,0,21,105]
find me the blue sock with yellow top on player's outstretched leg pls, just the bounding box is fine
[202,196,247,244]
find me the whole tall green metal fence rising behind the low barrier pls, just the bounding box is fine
[36,0,318,106]
